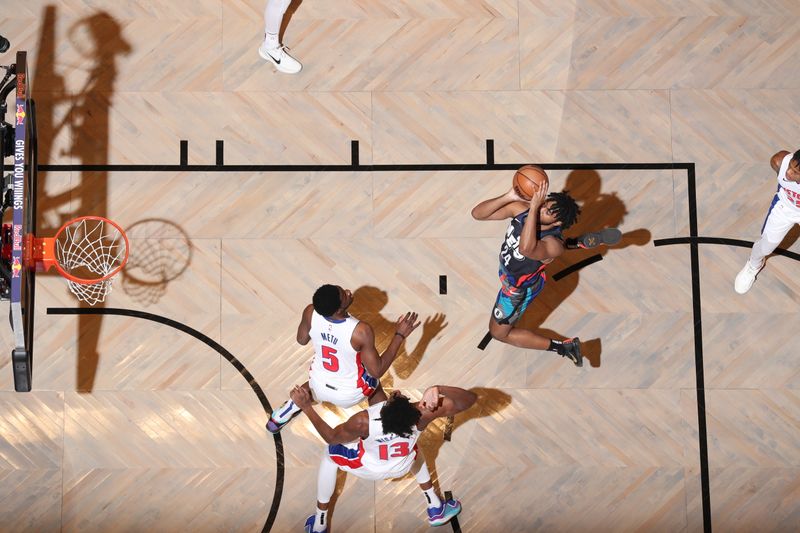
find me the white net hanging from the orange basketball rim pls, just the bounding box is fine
[55,217,128,305]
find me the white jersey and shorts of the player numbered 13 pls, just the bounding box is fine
[328,402,420,480]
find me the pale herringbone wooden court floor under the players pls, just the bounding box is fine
[0,0,800,532]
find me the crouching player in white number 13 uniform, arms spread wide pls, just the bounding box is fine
[291,385,478,533]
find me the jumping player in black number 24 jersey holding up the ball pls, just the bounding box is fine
[472,179,584,366]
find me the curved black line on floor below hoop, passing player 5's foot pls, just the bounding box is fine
[47,307,285,533]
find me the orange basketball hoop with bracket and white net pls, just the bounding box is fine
[23,216,129,305]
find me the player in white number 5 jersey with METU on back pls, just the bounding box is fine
[267,285,420,433]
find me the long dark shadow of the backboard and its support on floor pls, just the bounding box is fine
[33,5,131,392]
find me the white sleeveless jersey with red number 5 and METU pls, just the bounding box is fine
[308,311,364,389]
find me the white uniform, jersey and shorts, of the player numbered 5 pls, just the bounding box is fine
[308,311,378,407]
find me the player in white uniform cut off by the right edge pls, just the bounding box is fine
[733,150,800,294]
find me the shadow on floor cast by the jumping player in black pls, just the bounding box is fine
[517,170,652,368]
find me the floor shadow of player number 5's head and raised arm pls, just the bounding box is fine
[348,285,447,388]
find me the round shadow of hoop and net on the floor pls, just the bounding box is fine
[121,218,192,305]
